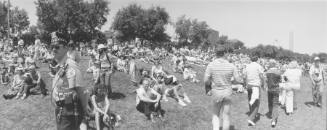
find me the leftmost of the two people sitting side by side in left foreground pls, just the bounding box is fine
[3,67,25,99]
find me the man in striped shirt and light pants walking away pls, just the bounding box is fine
[204,48,241,130]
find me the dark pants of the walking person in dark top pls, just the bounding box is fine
[268,91,279,120]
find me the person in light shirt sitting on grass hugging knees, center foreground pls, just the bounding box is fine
[136,78,163,122]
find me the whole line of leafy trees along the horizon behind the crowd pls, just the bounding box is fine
[0,0,327,62]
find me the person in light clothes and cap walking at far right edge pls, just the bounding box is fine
[309,57,325,107]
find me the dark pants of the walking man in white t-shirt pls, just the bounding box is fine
[247,87,260,121]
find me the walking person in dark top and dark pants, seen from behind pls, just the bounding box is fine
[266,60,282,127]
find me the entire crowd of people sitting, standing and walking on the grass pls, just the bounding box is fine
[0,34,325,130]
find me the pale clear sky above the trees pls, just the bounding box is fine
[5,0,327,54]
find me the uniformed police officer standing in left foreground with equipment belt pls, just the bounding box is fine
[52,41,89,130]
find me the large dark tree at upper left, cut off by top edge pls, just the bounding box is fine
[35,0,110,42]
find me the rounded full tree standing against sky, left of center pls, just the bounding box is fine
[111,4,170,45]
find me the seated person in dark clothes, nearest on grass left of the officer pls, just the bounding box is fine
[21,64,47,99]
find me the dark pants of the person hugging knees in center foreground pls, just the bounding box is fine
[136,101,161,119]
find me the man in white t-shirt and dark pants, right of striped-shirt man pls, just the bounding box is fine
[244,56,264,126]
